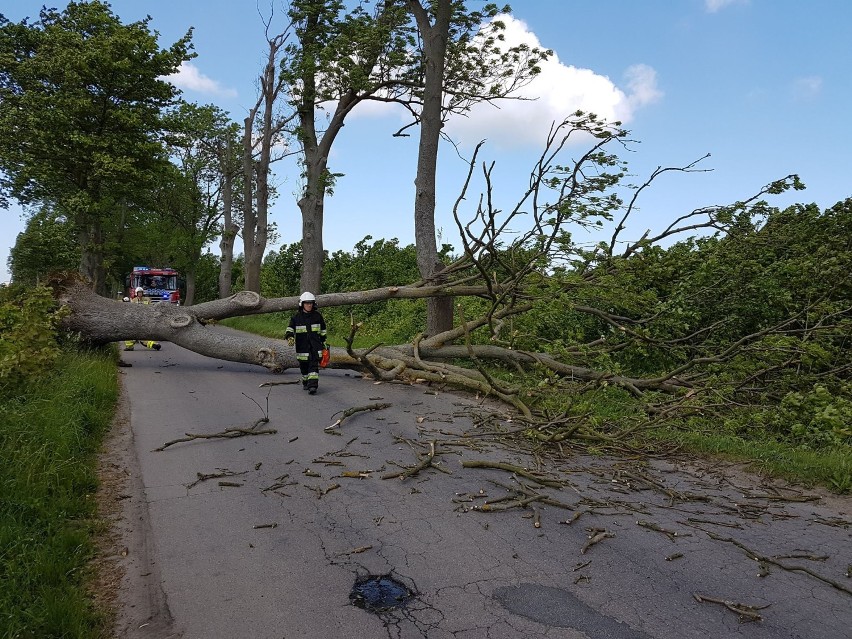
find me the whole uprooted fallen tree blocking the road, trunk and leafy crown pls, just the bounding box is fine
[51,113,850,442]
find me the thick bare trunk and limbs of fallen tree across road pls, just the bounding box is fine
[58,282,687,402]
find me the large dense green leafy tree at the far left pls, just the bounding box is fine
[0,0,192,292]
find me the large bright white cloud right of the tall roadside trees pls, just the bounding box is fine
[445,16,662,148]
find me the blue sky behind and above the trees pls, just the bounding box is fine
[0,0,852,281]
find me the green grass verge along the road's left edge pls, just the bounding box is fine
[0,353,118,639]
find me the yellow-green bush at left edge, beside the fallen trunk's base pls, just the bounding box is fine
[0,284,66,400]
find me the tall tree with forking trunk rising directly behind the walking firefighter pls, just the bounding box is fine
[282,0,410,292]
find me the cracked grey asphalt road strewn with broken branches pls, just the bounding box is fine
[114,343,852,639]
